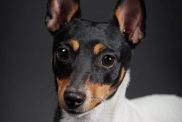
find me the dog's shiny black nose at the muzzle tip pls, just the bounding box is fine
[64,91,86,109]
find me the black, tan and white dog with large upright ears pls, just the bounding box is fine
[46,0,182,122]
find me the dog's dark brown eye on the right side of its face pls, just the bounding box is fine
[102,55,116,68]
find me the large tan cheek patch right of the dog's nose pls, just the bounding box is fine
[83,67,126,111]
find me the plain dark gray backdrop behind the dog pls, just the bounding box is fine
[0,0,182,122]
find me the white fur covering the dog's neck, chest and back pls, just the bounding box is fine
[60,72,182,122]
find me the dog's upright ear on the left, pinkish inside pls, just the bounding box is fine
[45,0,80,33]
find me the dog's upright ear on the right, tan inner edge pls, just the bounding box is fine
[115,0,145,45]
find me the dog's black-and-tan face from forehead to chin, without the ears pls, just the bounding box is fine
[53,19,131,112]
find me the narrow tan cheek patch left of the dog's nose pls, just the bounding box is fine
[57,78,69,106]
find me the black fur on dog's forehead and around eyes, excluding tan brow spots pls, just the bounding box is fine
[53,19,131,85]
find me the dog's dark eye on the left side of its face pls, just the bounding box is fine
[56,48,70,62]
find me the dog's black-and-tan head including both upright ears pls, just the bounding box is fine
[46,0,144,114]
